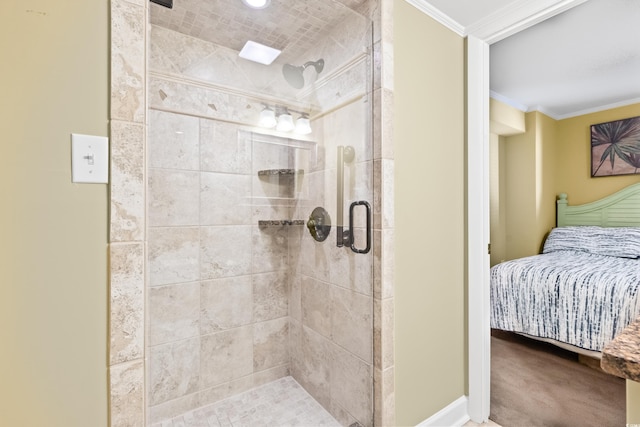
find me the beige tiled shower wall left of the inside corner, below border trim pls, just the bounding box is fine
[147,110,289,422]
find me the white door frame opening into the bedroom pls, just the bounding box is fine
[464,0,587,422]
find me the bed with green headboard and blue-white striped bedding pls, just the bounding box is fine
[490,183,640,358]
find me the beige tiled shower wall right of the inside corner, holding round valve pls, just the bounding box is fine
[290,100,373,426]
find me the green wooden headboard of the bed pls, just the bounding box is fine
[557,183,640,227]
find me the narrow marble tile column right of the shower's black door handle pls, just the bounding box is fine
[368,0,395,426]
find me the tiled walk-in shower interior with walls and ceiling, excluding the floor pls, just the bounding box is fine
[145,0,377,426]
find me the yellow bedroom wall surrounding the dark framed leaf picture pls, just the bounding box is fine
[555,103,640,204]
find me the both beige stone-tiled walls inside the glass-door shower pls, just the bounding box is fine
[148,19,373,425]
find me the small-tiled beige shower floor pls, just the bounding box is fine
[152,377,340,427]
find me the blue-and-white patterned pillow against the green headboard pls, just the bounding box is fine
[542,225,640,258]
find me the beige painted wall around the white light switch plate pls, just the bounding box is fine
[0,0,109,427]
